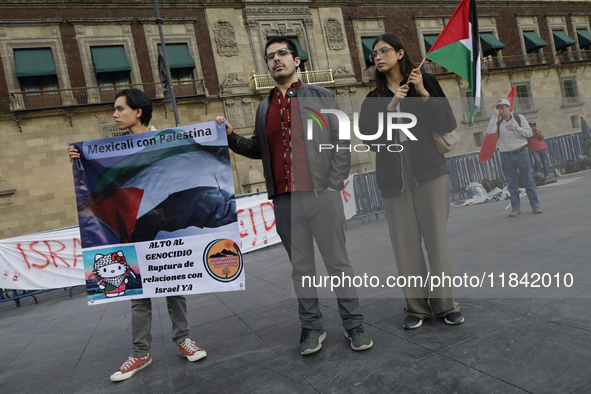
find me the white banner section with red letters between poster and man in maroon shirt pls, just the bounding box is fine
[236,193,281,253]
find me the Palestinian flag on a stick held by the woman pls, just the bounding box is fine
[425,0,481,126]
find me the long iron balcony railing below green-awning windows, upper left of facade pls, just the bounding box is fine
[0,79,205,113]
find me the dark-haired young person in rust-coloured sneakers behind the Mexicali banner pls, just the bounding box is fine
[68,89,207,382]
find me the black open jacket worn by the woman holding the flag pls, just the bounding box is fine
[359,74,457,197]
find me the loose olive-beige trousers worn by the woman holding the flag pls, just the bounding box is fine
[383,150,460,319]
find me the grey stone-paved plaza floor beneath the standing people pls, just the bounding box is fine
[0,171,591,394]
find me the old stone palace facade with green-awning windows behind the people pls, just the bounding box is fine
[0,0,591,238]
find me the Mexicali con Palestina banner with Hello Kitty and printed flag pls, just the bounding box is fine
[73,122,245,304]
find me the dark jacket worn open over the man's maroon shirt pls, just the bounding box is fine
[228,83,351,198]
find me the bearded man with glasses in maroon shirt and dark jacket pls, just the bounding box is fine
[217,36,373,355]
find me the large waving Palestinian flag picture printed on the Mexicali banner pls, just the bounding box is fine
[76,130,237,248]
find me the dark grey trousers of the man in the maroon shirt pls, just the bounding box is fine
[273,190,363,330]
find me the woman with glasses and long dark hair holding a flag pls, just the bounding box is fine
[360,33,464,329]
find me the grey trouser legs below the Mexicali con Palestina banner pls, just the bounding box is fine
[131,296,191,357]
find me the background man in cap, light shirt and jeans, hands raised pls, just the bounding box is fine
[486,99,544,217]
